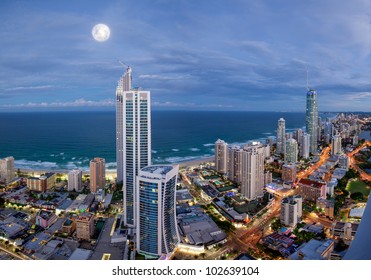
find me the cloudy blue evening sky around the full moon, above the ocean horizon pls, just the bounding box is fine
[0,0,371,111]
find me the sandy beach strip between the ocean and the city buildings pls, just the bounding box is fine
[14,156,214,177]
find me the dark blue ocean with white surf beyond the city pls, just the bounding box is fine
[0,111,305,172]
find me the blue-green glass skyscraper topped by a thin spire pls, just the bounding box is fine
[305,89,318,154]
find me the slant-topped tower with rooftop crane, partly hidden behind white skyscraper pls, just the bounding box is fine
[116,67,132,182]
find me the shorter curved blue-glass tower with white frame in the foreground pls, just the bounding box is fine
[136,165,180,258]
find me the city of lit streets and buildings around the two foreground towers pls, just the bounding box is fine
[0,113,371,260]
